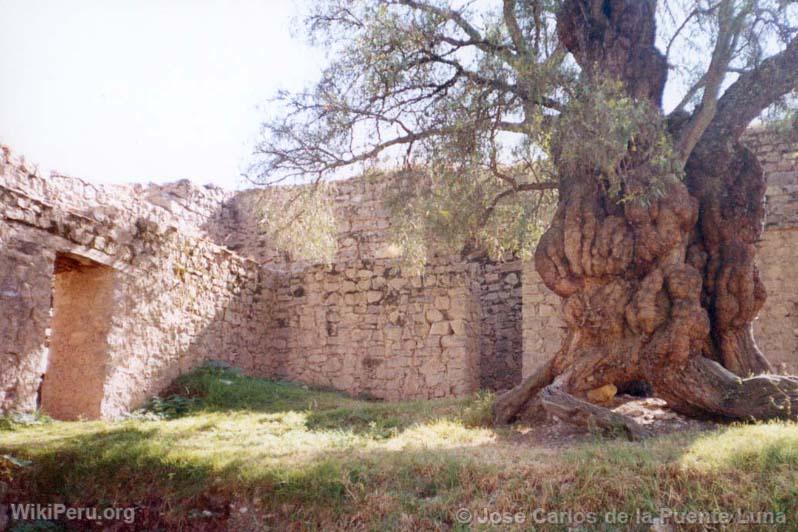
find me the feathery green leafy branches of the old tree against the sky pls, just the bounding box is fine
[252,0,798,262]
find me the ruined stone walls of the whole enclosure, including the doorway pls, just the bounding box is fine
[0,130,798,419]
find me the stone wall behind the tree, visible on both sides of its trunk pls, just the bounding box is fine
[523,128,798,376]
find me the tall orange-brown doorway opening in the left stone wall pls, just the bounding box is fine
[40,253,115,420]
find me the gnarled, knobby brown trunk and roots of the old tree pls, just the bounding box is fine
[494,0,798,432]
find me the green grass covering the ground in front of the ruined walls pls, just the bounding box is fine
[0,369,798,530]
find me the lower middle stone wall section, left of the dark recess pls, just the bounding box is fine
[268,259,479,399]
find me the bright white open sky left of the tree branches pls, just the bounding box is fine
[0,0,324,189]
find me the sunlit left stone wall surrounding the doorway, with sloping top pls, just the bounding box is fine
[0,149,273,417]
